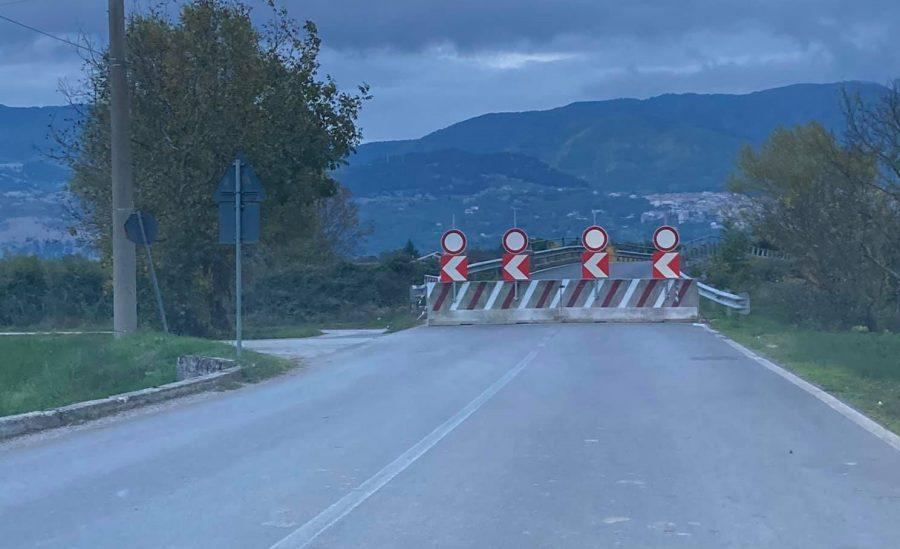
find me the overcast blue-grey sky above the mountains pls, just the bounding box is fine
[0,0,900,141]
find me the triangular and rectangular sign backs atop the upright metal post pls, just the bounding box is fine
[213,155,266,244]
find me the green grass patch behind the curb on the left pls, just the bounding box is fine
[0,332,294,416]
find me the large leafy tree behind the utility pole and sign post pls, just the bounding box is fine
[67,0,369,334]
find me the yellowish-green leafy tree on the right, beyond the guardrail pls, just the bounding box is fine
[731,123,897,330]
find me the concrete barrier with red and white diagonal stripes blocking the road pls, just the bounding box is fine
[426,278,700,325]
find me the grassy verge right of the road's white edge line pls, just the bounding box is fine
[711,315,900,433]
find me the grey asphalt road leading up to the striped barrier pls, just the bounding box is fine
[0,324,900,548]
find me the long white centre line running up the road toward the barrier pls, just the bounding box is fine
[271,346,546,549]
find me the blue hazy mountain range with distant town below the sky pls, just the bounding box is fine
[0,82,885,254]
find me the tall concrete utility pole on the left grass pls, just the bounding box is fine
[109,0,137,337]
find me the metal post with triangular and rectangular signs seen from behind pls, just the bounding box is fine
[214,154,266,358]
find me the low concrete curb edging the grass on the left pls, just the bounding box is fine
[0,366,241,441]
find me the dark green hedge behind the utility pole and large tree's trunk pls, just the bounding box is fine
[0,246,434,336]
